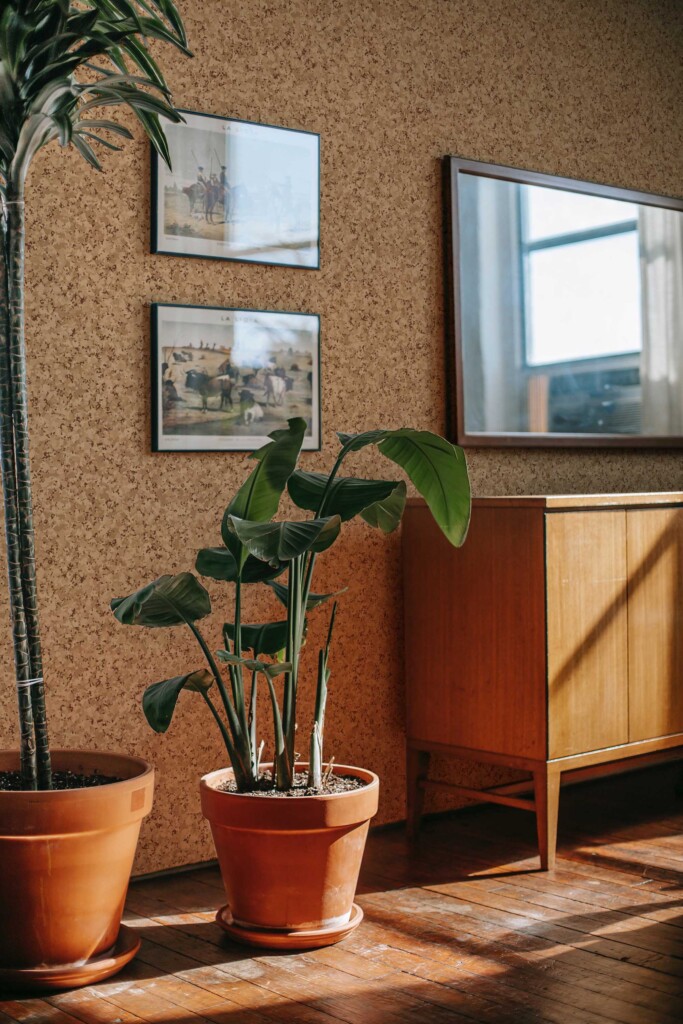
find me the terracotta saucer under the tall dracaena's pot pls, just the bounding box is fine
[0,925,140,992]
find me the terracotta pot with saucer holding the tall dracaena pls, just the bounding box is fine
[0,751,154,987]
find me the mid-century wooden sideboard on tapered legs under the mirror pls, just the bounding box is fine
[402,493,683,867]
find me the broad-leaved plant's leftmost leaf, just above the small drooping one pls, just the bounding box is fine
[112,572,211,628]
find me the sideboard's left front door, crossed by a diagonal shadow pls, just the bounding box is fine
[546,509,629,758]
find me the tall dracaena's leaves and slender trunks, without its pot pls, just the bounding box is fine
[0,0,189,788]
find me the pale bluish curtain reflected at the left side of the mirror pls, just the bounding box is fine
[460,175,526,433]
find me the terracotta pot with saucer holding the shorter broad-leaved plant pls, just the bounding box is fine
[201,764,379,948]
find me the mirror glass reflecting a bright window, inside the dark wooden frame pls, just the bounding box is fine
[452,166,683,443]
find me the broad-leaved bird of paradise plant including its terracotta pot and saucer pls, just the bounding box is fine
[112,419,470,948]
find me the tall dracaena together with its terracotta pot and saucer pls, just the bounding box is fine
[0,0,189,988]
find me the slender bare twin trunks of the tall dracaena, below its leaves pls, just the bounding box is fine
[0,187,52,788]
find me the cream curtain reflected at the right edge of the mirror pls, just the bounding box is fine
[638,206,683,435]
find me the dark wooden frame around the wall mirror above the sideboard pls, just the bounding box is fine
[441,156,683,449]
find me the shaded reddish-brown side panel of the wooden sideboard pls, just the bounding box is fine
[402,507,546,760]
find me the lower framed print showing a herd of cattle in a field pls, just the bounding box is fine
[152,302,321,452]
